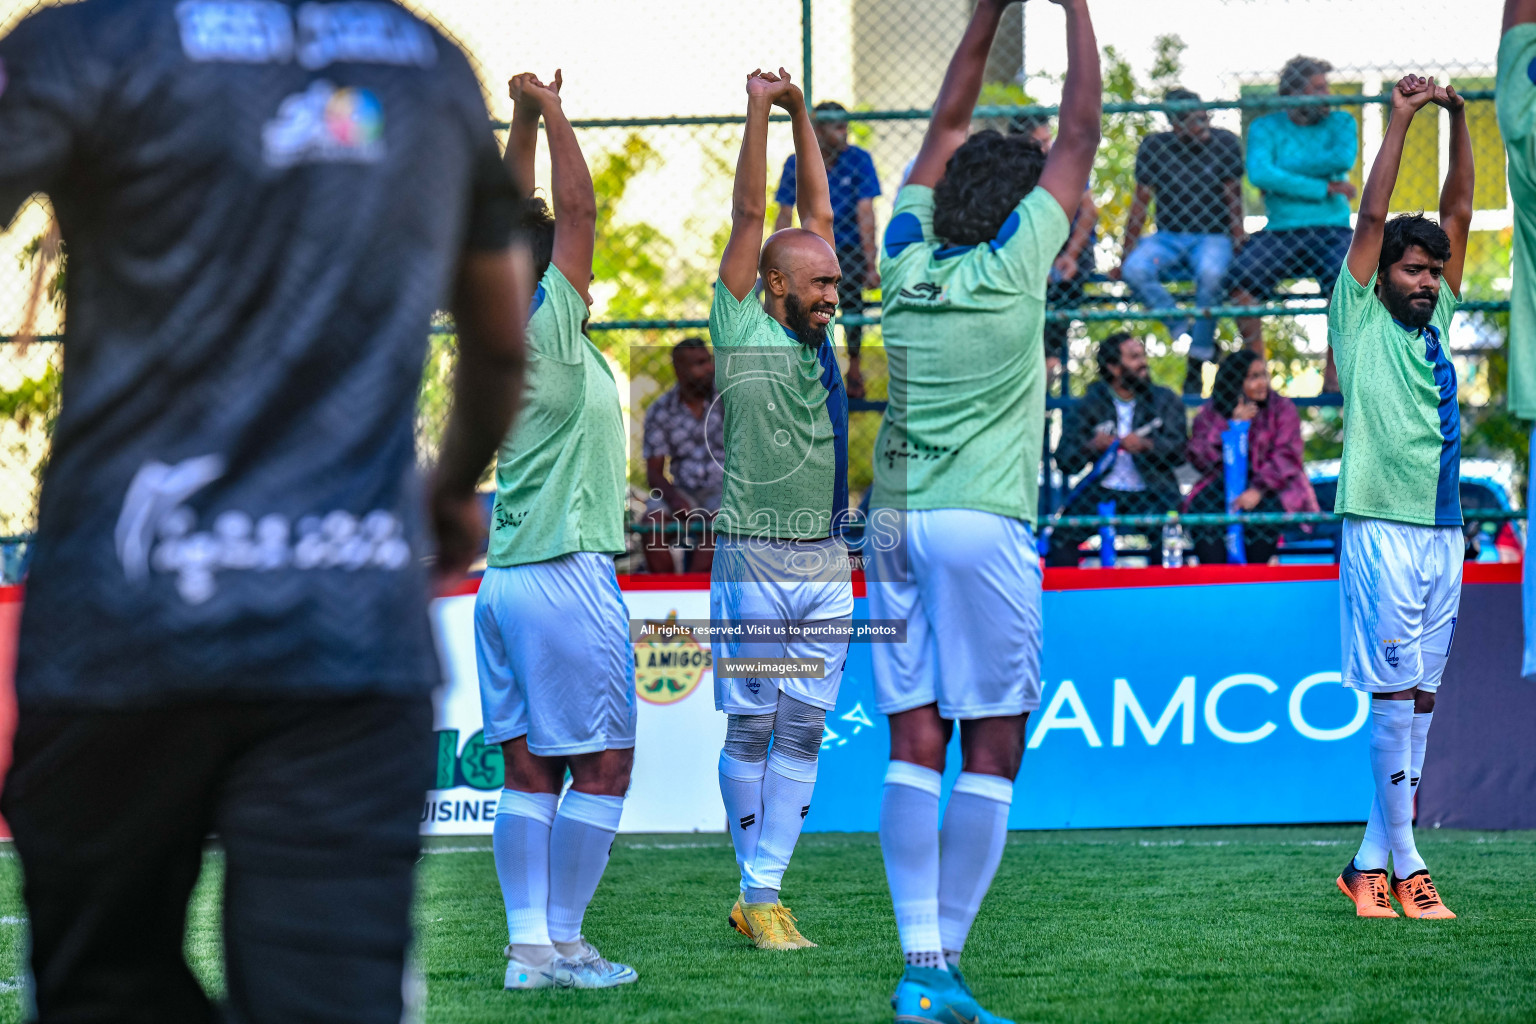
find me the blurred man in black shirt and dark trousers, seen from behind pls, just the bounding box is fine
[0,0,528,1024]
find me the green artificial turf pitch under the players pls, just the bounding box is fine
[0,826,1536,1024]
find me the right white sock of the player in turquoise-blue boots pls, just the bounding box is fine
[938,772,1014,966]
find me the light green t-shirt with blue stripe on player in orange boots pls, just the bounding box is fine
[1329,263,1461,527]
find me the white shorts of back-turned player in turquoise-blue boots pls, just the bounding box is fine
[866,508,1043,720]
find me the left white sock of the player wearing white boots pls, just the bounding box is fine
[492,789,559,963]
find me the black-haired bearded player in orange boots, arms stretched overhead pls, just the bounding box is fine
[1329,75,1473,918]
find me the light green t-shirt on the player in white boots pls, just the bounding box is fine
[485,264,627,568]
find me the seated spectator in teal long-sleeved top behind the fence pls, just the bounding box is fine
[1229,57,1359,391]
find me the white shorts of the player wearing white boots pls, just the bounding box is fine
[475,551,634,757]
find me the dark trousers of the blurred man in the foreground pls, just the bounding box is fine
[0,697,433,1024]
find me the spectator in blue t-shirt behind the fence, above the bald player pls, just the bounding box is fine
[773,100,880,398]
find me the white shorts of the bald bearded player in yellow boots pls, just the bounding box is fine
[710,536,854,715]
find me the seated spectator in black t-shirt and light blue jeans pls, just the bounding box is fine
[1109,89,1247,395]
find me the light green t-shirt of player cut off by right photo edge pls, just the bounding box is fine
[1496,23,1536,419]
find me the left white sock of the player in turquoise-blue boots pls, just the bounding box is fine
[880,761,948,970]
